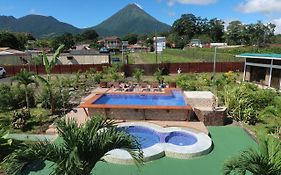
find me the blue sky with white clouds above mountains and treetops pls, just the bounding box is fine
[0,0,281,33]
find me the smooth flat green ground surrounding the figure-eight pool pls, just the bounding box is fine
[24,126,256,175]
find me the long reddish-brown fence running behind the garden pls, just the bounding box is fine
[2,62,244,76]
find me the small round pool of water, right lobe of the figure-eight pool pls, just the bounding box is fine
[165,132,197,146]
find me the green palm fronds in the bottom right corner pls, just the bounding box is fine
[224,136,281,175]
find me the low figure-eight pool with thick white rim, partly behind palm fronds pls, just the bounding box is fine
[104,122,212,164]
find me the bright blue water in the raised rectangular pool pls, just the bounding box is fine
[93,90,186,106]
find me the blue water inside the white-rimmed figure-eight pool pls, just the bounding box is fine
[118,126,197,148]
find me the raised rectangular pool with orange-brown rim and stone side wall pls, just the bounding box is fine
[80,88,193,121]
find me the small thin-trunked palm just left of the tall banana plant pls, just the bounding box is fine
[13,69,36,113]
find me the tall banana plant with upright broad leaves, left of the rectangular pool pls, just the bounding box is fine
[36,45,64,113]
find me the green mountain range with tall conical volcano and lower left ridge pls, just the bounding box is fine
[0,4,170,38]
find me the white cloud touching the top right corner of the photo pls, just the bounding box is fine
[237,0,281,13]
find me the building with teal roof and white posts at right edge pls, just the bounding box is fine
[236,53,281,89]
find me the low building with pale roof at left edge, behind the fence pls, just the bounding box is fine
[0,47,31,65]
